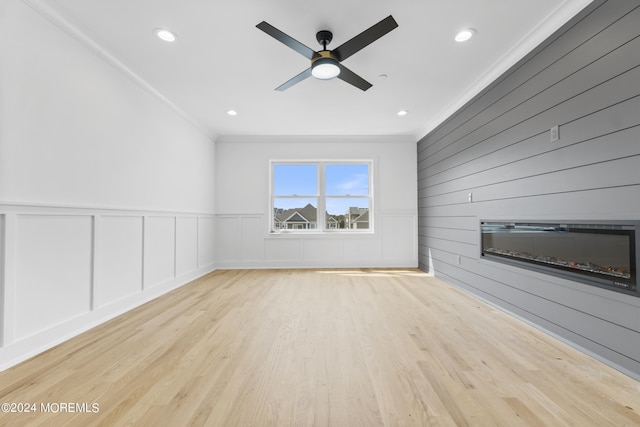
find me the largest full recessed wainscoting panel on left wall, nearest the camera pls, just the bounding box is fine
[14,215,93,339]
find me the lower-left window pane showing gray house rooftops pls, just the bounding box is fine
[273,197,318,230]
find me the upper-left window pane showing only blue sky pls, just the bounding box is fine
[273,165,318,196]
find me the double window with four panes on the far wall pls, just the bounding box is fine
[270,161,373,232]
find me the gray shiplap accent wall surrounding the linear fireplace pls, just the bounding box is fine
[418,0,640,379]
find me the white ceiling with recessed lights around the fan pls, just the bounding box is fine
[24,0,590,138]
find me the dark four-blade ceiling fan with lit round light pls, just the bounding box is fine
[256,15,398,91]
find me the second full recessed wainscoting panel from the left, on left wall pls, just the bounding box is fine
[94,216,143,307]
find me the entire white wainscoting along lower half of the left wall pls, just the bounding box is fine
[0,204,215,370]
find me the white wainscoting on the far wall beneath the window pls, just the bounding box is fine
[216,211,418,268]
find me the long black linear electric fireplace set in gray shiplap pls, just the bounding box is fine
[480,221,640,296]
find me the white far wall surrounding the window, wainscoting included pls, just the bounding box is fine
[215,136,418,268]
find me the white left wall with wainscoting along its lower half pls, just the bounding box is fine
[0,0,215,369]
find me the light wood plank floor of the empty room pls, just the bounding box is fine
[0,270,640,427]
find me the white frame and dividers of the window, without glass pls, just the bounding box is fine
[268,159,375,235]
